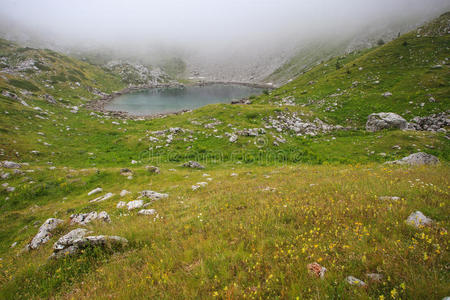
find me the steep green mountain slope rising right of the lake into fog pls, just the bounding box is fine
[258,13,450,126]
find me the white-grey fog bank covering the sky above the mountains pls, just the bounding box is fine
[0,0,450,77]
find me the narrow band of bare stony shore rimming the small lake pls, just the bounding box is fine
[85,81,275,120]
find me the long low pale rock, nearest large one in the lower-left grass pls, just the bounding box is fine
[50,228,128,258]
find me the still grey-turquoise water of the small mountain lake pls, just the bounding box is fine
[105,84,262,115]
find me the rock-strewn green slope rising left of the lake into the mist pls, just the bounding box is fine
[0,40,125,105]
